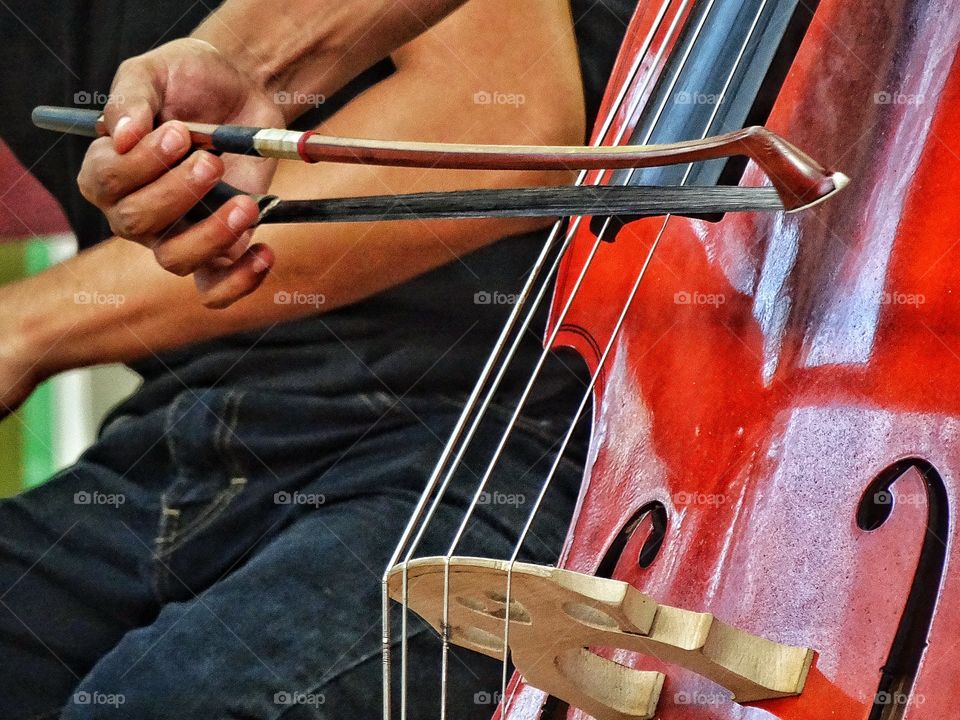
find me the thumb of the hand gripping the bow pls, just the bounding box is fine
[103,56,165,154]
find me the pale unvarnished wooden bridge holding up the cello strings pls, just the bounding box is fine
[389,557,814,720]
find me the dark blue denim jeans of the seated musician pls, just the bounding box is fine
[0,390,581,720]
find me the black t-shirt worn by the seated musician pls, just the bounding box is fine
[0,0,637,414]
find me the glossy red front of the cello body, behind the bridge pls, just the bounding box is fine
[504,0,960,720]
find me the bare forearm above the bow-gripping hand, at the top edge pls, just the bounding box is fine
[193,0,465,120]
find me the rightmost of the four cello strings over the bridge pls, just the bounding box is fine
[501,0,768,716]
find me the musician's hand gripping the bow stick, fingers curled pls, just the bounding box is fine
[79,38,283,307]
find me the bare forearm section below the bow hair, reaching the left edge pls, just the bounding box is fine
[7,208,548,378]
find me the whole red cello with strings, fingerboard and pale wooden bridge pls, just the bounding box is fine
[384,0,960,720]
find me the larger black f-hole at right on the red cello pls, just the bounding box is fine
[857,458,950,720]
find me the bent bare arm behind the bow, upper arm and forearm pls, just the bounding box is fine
[13,0,583,382]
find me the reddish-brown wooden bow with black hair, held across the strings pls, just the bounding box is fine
[33,106,849,225]
